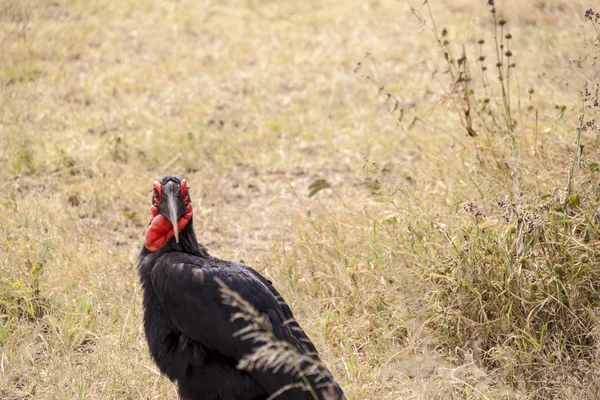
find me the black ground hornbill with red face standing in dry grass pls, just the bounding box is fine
[138,175,344,400]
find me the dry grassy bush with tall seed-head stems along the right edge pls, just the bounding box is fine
[357,0,600,397]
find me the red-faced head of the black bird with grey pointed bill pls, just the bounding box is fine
[145,175,192,252]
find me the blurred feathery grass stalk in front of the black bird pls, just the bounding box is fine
[217,279,342,400]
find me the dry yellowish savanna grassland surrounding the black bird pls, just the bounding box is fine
[0,0,600,399]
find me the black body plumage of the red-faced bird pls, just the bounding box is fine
[138,175,344,400]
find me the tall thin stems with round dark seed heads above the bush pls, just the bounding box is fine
[355,0,528,198]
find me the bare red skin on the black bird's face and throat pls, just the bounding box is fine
[145,179,192,252]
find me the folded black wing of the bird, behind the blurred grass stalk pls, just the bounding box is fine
[151,253,342,399]
